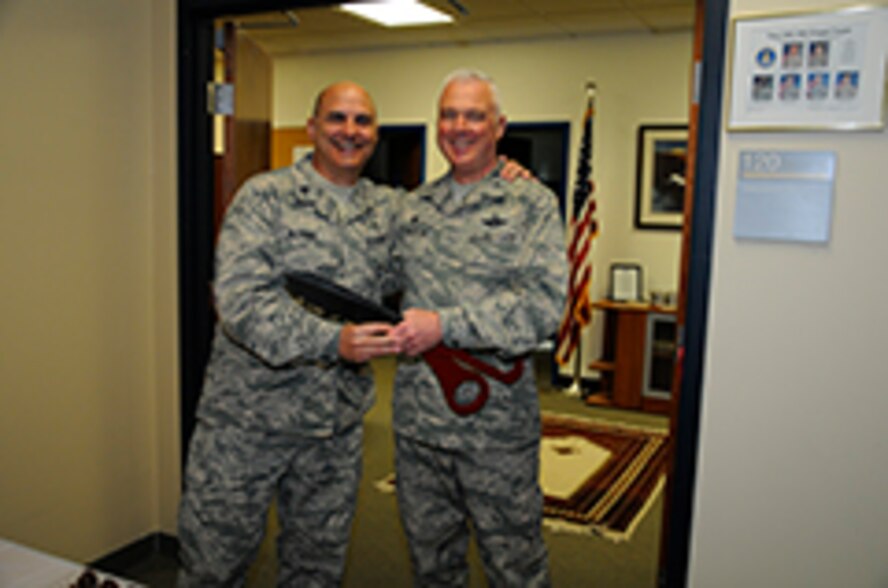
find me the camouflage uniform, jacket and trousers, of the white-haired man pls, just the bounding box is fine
[394,170,567,586]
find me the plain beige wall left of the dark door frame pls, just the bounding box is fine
[0,0,179,560]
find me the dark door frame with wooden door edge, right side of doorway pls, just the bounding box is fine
[660,0,727,586]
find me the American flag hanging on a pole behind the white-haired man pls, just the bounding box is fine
[555,84,598,365]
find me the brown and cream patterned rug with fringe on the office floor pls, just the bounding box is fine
[376,412,669,542]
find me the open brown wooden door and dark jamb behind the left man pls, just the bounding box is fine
[179,21,271,450]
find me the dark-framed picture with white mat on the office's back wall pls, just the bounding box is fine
[635,125,688,230]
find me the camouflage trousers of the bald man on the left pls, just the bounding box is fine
[178,423,363,588]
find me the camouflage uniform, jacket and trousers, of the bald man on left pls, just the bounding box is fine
[179,158,393,587]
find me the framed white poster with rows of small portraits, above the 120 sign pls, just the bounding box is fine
[728,6,888,131]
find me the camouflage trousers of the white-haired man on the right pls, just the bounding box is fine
[396,436,550,588]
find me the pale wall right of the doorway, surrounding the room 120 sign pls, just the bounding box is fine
[690,0,888,588]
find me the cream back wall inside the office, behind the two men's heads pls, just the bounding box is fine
[273,32,692,372]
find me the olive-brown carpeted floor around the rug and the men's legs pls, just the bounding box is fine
[114,352,667,588]
